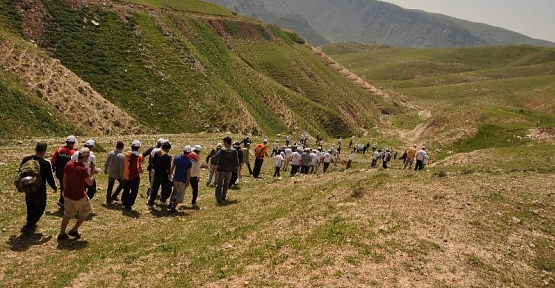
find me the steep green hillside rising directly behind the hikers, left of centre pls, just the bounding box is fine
[0,0,390,136]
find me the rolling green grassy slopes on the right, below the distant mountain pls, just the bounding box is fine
[325,46,555,151]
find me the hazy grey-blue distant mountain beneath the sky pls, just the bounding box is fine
[209,0,555,47]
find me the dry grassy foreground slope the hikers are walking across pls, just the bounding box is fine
[0,135,555,287]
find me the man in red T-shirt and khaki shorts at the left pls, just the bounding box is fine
[58,147,95,241]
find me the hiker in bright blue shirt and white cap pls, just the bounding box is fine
[167,145,193,213]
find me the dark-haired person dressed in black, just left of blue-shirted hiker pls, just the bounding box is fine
[148,142,173,210]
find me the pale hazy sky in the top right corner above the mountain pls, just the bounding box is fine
[381,0,555,42]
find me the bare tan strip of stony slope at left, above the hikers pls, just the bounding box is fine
[0,39,143,135]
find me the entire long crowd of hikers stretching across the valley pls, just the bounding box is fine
[14,133,430,241]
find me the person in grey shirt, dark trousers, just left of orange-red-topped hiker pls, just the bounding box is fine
[104,141,125,205]
